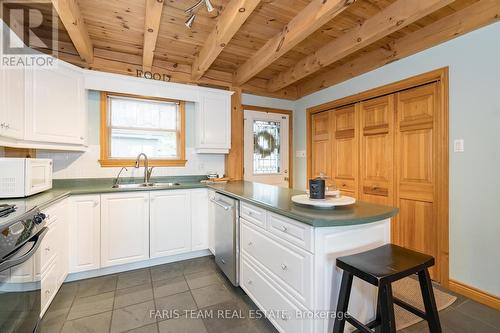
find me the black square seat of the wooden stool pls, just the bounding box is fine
[337,244,434,286]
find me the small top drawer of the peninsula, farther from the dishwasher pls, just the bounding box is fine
[268,213,314,252]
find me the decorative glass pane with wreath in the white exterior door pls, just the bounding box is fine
[253,120,281,174]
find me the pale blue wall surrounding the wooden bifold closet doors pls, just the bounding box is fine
[294,23,500,296]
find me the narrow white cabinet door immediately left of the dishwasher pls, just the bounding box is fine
[191,189,209,251]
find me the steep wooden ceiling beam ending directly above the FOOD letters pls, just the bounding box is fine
[142,0,163,71]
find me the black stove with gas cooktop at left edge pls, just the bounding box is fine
[0,204,48,333]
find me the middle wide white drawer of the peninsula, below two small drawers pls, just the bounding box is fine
[241,223,313,307]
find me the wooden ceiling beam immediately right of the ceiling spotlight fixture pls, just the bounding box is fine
[191,0,260,80]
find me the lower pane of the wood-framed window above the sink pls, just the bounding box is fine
[110,129,178,159]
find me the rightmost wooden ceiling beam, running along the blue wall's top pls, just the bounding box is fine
[298,0,500,97]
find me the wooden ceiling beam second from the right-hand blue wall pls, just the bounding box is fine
[268,0,455,91]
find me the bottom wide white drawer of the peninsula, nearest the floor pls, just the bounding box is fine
[241,257,312,333]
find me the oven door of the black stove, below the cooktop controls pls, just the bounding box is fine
[0,228,47,333]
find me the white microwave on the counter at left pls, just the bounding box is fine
[0,157,52,198]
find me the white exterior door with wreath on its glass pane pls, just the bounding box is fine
[244,110,290,187]
